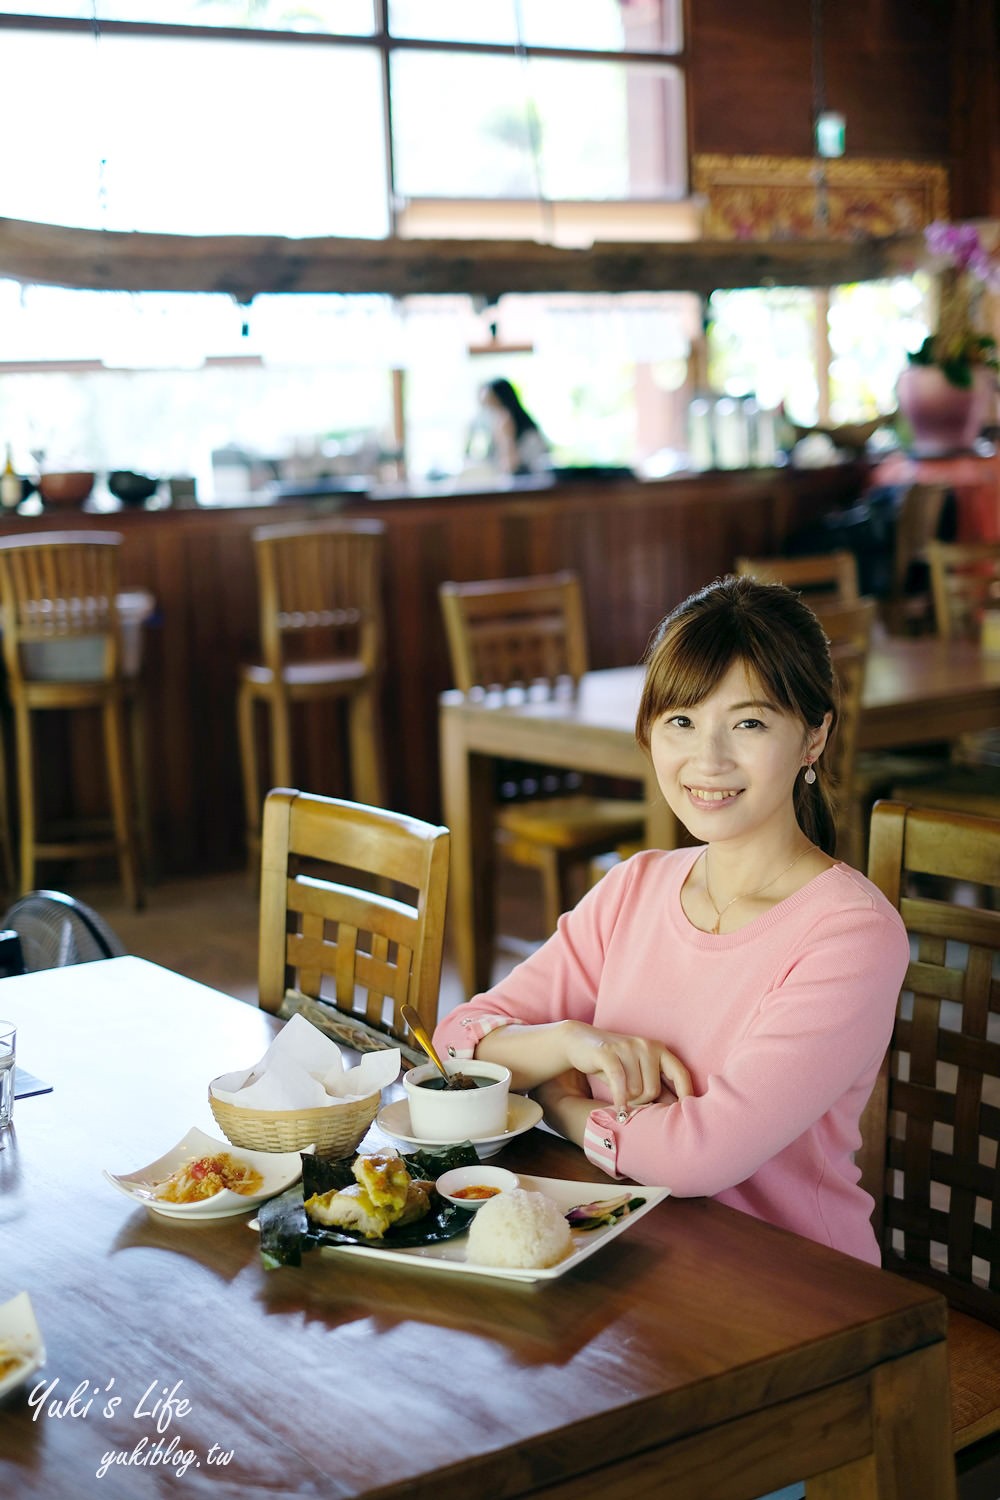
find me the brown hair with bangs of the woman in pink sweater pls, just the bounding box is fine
[636,578,838,855]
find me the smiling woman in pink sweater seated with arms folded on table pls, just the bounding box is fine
[435,578,909,1265]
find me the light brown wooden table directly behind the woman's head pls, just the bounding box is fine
[441,636,1000,998]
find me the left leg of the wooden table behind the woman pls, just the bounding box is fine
[441,705,496,999]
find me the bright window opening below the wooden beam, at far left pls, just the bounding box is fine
[0,281,397,486]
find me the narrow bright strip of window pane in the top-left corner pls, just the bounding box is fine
[0,0,375,36]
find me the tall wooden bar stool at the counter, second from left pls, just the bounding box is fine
[237,521,385,872]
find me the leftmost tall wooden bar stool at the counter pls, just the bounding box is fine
[0,531,142,908]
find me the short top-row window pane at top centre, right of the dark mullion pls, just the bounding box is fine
[388,0,681,53]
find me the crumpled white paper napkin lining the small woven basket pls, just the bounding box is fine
[211,1016,400,1110]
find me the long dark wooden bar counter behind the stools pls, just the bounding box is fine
[0,465,864,878]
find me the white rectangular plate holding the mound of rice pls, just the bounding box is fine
[319,1172,670,1281]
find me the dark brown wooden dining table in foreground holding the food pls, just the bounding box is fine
[0,957,955,1500]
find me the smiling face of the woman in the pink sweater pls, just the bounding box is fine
[649,662,829,842]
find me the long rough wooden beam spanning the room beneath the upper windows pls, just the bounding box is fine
[0,219,922,303]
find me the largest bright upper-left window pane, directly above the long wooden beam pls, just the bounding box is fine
[0,32,388,236]
